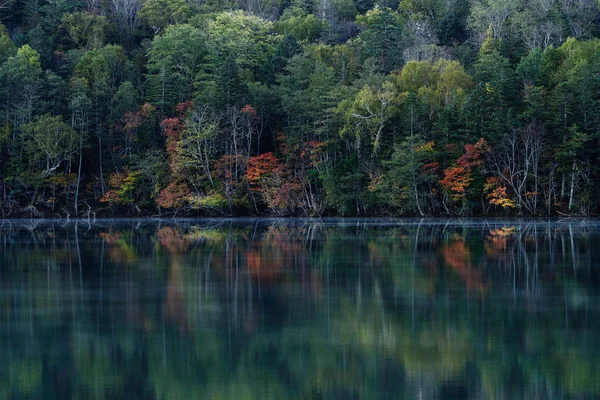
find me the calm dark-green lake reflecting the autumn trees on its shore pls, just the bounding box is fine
[0,219,600,400]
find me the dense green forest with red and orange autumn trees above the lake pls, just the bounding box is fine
[0,0,600,217]
